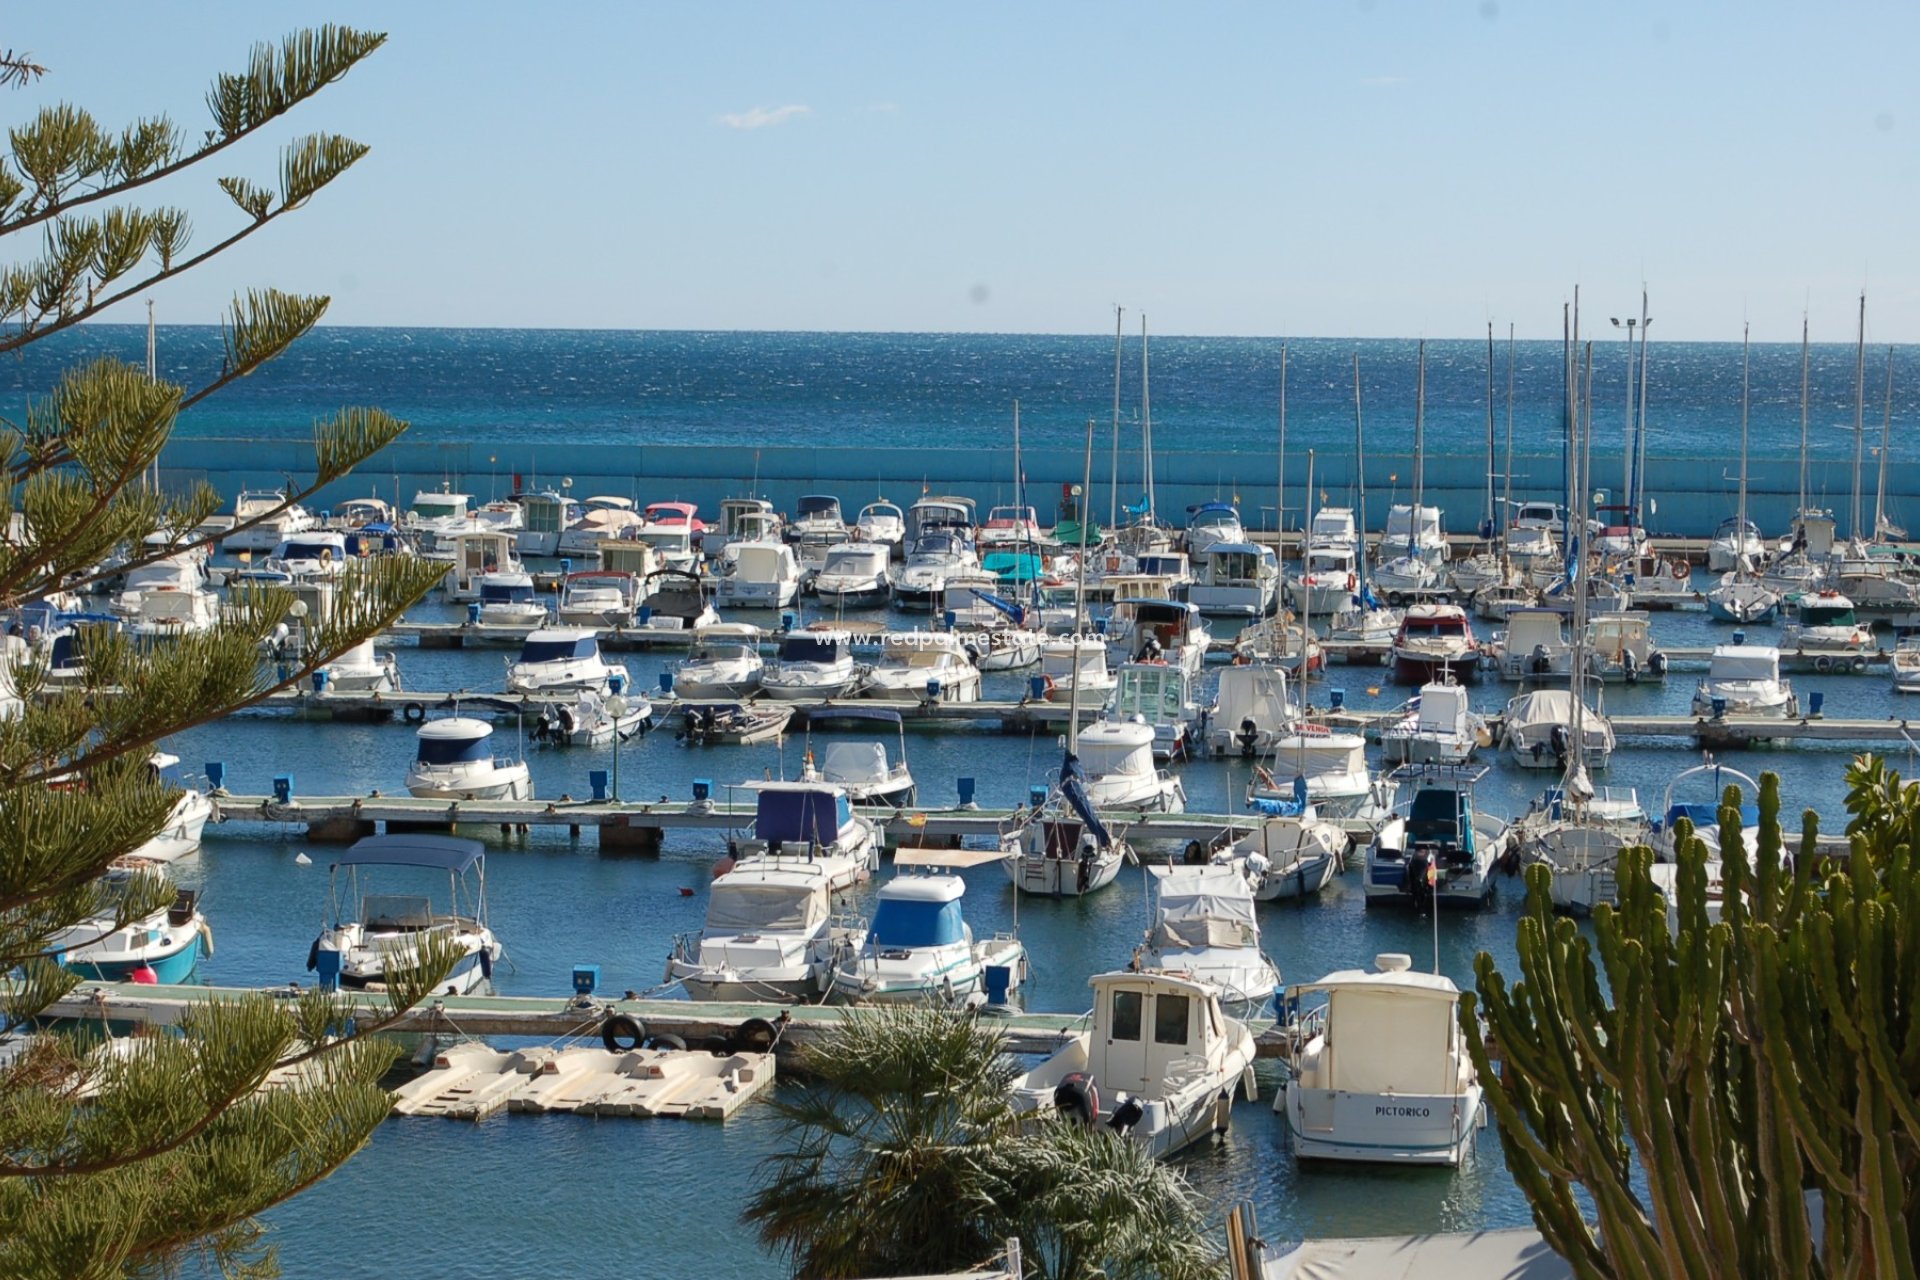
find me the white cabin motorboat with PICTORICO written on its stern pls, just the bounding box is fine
[1275,954,1482,1167]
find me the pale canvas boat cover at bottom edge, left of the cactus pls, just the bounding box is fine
[1260,1226,1572,1280]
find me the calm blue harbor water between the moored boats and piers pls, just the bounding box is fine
[142,583,1881,1278]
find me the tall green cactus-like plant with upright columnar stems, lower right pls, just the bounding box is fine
[1461,756,1920,1280]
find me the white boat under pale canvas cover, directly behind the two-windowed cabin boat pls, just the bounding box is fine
[1133,865,1281,1019]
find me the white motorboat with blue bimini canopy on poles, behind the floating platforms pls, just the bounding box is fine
[307,835,505,996]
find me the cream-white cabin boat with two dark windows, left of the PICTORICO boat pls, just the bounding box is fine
[1012,969,1256,1157]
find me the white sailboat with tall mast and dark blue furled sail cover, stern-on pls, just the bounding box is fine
[1000,418,1133,898]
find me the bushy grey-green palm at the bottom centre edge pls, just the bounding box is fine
[743,1006,1221,1280]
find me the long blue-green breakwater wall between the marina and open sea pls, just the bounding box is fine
[161,438,1920,537]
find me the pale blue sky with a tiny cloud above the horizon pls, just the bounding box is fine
[15,0,1920,342]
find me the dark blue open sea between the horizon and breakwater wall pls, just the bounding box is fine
[0,324,1920,460]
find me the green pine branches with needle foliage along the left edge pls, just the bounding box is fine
[0,27,457,1278]
